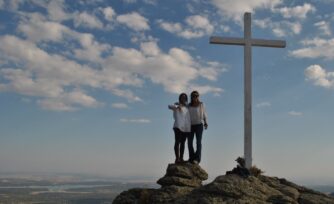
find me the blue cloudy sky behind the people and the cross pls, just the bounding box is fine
[0,0,334,184]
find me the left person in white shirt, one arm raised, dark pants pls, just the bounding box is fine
[168,93,191,163]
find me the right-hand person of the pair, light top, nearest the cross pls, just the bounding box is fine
[188,91,208,164]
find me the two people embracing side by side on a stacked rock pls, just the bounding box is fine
[168,91,208,164]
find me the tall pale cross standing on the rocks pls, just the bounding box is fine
[210,13,286,169]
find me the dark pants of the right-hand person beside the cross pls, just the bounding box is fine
[188,124,203,162]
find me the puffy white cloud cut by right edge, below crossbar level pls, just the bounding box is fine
[304,64,334,88]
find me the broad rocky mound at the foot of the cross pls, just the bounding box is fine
[177,174,334,204]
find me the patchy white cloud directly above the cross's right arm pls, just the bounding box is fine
[254,18,302,37]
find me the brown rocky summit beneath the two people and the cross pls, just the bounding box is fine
[113,163,334,204]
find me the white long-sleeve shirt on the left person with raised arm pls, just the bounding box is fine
[168,105,191,132]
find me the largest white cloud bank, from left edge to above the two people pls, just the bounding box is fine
[0,34,224,111]
